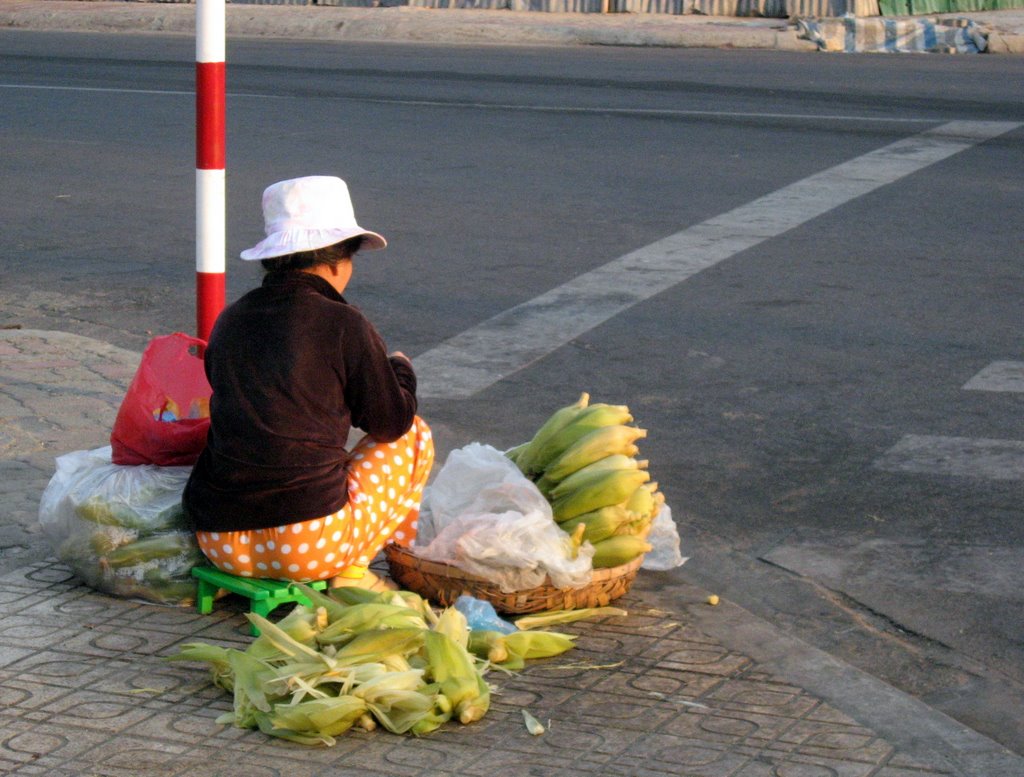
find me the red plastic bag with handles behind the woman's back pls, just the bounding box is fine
[111,332,213,467]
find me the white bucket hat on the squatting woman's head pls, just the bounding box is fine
[242,175,387,260]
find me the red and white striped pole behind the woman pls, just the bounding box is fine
[196,0,226,340]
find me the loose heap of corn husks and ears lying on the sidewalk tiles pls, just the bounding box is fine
[169,586,606,745]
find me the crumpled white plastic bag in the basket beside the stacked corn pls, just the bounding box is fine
[412,442,594,593]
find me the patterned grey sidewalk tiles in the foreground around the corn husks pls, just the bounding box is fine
[0,560,947,777]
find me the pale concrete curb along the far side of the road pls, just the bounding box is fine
[0,0,1024,54]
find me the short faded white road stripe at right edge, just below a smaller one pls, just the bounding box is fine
[874,434,1024,480]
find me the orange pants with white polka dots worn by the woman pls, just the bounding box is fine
[196,417,434,581]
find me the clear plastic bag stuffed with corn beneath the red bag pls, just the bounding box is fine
[39,445,203,605]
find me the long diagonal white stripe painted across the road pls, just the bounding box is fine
[414,121,1022,399]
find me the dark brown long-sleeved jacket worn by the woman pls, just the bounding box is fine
[183,271,417,531]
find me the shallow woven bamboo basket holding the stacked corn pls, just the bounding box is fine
[384,543,643,615]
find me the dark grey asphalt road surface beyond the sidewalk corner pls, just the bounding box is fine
[0,32,1024,752]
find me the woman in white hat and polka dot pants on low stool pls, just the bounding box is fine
[183,176,434,588]
